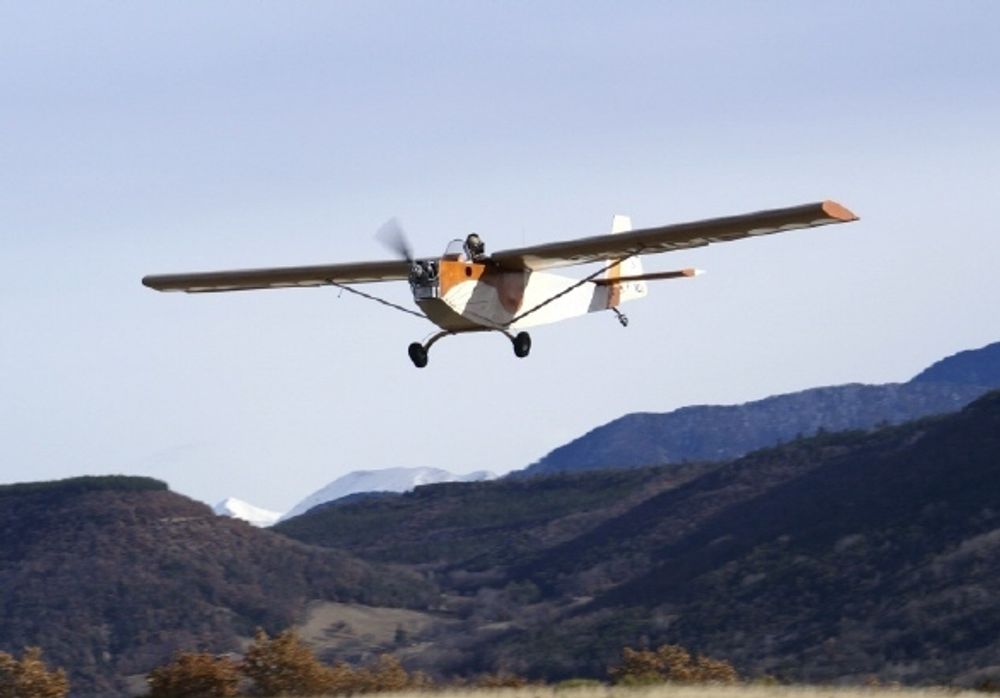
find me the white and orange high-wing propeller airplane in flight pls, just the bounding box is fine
[142,201,858,368]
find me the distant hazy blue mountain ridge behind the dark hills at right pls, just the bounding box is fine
[512,342,1000,477]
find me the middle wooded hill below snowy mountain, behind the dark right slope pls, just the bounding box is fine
[274,464,711,572]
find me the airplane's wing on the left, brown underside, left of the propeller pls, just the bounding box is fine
[142,260,410,293]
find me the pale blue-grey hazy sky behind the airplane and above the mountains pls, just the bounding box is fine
[0,0,1000,511]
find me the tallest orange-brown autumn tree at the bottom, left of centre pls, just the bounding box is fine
[240,629,337,696]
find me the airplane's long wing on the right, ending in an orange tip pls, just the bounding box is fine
[490,201,858,270]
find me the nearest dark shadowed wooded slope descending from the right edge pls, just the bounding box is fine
[487,393,1000,685]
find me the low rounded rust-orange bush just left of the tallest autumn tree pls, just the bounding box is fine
[146,652,240,698]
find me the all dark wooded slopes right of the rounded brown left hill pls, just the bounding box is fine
[283,393,1000,683]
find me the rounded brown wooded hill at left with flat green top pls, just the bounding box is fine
[0,478,430,695]
